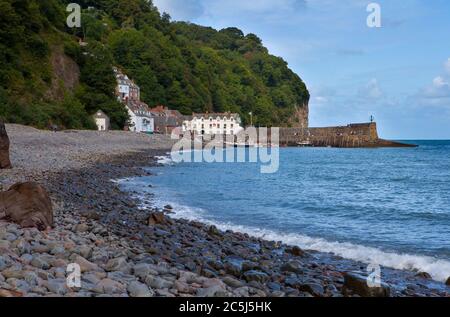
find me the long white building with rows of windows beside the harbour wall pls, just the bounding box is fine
[183,113,244,135]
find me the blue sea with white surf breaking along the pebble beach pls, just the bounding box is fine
[121,141,450,281]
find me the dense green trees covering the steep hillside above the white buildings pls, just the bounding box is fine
[0,0,309,129]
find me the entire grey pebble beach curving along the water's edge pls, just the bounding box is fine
[0,125,450,297]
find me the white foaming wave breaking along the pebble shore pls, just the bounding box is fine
[150,196,450,282]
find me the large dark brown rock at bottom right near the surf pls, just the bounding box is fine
[342,273,391,297]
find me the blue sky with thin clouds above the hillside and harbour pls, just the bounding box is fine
[153,0,450,139]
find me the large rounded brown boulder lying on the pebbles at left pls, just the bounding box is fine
[0,183,53,231]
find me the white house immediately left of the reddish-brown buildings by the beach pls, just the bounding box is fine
[126,101,155,133]
